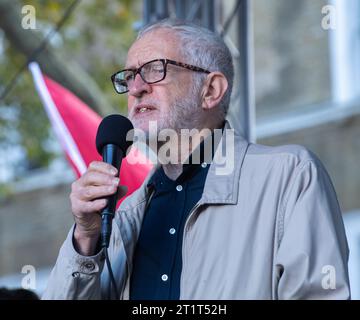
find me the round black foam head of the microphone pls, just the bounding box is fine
[96,114,134,154]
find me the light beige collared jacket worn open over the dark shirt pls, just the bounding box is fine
[43,123,350,299]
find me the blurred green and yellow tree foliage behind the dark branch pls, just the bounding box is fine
[0,0,141,182]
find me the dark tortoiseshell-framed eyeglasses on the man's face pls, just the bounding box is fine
[111,59,210,94]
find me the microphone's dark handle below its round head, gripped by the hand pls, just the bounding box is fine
[101,144,124,248]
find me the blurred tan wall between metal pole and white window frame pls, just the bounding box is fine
[253,0,331,119]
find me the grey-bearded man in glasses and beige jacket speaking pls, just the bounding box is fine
[43,19,350,300]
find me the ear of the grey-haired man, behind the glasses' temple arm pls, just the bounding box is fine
[201,71,229,109]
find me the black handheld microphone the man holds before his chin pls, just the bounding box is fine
[96,114,134,248]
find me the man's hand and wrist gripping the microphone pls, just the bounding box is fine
[70,161,126,256]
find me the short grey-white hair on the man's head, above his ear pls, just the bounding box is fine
[137,19,234,117]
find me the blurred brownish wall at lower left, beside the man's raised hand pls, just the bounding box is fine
[0,184,73,276]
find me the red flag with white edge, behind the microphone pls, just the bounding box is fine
[29,62,152,205]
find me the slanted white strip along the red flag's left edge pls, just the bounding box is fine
[29,62,86,175]
